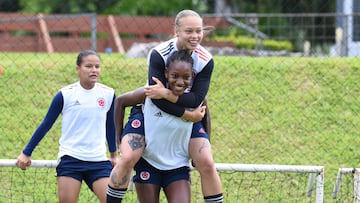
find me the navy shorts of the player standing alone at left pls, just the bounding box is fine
[56,155,112,190]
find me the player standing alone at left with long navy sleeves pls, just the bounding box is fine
[16,50,116,203]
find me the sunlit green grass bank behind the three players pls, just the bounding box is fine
[0,53,360,200]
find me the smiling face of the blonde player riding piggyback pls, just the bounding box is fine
[175,15,204,51]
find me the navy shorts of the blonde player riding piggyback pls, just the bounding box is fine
[121,106,209,139]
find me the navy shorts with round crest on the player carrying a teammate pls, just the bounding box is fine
[133,158,190,188]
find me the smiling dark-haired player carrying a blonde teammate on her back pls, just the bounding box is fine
[121,50,205,203]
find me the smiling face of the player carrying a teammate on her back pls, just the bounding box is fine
[165,60,192,96]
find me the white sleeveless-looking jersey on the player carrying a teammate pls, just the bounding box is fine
[142,98,193,170]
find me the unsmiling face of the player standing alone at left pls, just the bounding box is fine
[76,54,100,89]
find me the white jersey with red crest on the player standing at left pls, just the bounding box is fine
[58,82,114,161]
